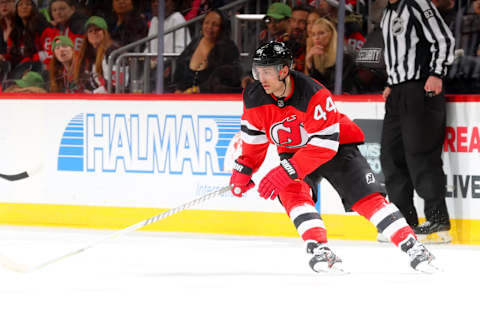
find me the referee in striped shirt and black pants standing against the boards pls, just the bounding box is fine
[380,0,455,242]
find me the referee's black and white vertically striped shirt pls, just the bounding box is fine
[380,0,455,85]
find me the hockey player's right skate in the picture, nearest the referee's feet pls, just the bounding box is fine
[400,237,439,273]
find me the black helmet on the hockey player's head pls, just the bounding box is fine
[252,41,293,80]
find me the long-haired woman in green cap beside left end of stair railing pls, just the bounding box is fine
[73,16,118,93]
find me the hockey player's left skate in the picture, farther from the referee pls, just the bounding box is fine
[307,241,345,274]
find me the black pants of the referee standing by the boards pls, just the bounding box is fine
[380,80,449,227]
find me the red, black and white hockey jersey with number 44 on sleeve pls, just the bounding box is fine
[239,71,364,178]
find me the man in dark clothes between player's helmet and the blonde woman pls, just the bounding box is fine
[286,5,310,72]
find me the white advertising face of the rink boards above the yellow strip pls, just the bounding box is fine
[0,96,480,242]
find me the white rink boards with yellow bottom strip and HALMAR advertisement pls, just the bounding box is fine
[0,95,480,244]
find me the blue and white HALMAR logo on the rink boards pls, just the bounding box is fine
[57,113,240,175]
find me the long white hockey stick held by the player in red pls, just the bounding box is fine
[0,186,232,273]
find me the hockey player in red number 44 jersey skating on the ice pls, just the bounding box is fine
[230,42,437,272]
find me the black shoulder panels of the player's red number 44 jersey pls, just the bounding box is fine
[243,71,324,112]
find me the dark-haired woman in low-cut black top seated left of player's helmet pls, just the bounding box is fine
[174,9,242,93]
